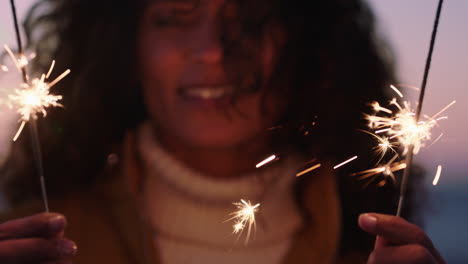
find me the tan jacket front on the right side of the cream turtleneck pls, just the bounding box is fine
[285,163,341,263]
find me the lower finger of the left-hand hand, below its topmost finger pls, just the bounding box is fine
[0,238,77,264]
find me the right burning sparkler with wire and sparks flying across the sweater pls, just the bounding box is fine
[229,0,455,243]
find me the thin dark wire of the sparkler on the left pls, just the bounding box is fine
[10,0,49,212]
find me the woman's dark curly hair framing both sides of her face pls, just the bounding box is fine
[1,0,424,258]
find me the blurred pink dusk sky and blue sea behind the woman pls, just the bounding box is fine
[0,0,468,264]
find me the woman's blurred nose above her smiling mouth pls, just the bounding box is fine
[192,20,223,64]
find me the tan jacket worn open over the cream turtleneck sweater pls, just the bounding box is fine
[3,135,366,264]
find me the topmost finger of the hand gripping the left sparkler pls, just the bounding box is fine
[0,213,66,241]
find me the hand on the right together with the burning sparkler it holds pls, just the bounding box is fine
[359,0,448,264]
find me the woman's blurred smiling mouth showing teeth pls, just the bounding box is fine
[180,85,234,100]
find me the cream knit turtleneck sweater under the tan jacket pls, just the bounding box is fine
[138,123,302,264]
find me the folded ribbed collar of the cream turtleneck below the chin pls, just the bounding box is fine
[139,123,298,204]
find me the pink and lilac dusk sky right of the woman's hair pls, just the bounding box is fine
[370,0,468,187]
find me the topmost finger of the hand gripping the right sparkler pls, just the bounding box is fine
[359,213,443,262]
